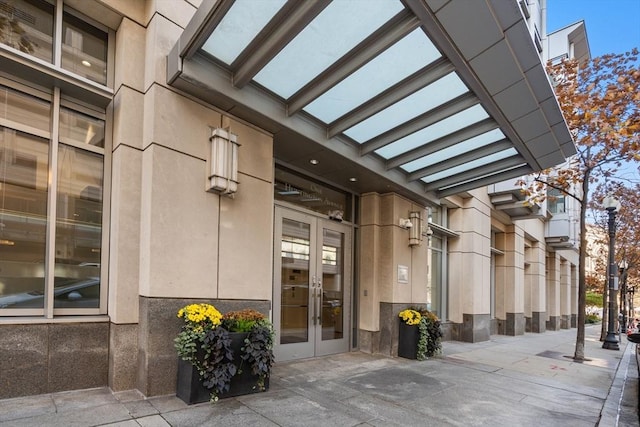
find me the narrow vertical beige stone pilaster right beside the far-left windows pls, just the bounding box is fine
[108,5,146,324]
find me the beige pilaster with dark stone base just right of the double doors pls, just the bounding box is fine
[358,193,428,356]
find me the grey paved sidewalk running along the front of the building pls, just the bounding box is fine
[0,326,639,427]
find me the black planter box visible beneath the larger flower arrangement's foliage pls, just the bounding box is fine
[176,332,269,405]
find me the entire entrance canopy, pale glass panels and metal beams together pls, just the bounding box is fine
[169,0,573,200]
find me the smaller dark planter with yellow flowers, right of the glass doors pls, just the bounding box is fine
[398,307,442,360]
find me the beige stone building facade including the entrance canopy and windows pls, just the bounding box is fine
[0,0,577,398]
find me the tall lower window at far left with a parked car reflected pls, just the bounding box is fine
[0,81,105,317]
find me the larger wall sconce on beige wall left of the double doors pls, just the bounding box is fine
[207,128,240,197]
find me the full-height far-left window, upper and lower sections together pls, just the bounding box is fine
[0,0,109,318]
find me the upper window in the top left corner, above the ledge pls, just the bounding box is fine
[0,0,108,85]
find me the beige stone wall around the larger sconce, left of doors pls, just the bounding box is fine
[109,0,273,323]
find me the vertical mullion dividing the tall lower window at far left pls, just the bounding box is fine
[44,87,60,319]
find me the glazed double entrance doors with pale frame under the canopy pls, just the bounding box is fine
[273,207,351,361]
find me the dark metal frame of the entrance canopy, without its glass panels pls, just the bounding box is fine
[167,0,575,202]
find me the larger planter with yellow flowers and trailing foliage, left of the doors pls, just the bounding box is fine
[175,304,274,403]
